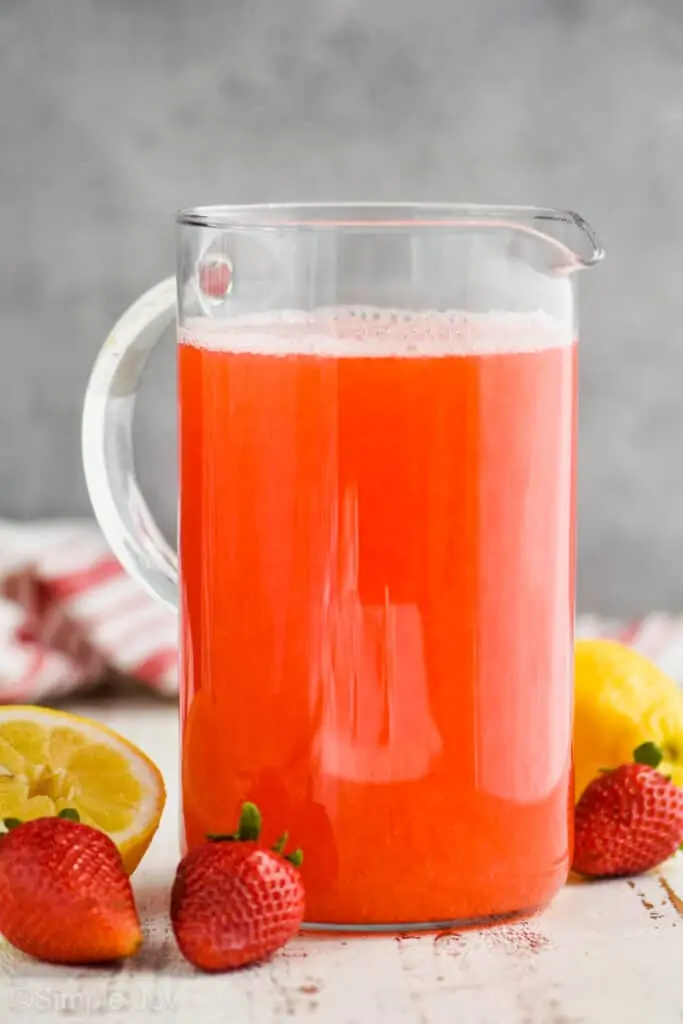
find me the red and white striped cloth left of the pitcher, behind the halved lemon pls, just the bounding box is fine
[0,520,177,703]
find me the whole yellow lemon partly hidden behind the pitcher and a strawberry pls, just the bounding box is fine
[573,640,683,800]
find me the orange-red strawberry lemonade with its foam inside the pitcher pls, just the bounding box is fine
[179,308,577,926]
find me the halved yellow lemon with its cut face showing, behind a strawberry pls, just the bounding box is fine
[0,706,166,874]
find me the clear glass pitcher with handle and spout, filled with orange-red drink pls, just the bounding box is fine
[83,205,602,929]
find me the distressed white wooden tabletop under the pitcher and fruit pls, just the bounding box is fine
[0,697,683,1024]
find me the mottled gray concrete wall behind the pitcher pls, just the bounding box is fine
[0,0,683,614]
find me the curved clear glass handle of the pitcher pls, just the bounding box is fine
[82,278,178,609]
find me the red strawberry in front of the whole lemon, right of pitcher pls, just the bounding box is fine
[572,742,683,878]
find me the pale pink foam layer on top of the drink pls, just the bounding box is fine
[178,306,573,358]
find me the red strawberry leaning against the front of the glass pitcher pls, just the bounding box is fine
[171,803,304,971]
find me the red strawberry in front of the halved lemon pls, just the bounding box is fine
[0,810,142,964]
